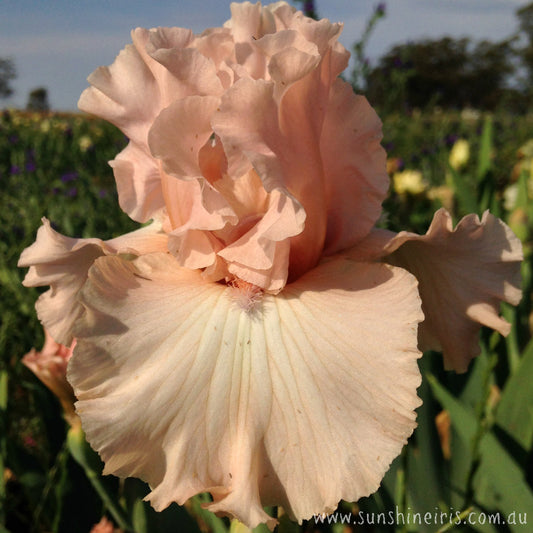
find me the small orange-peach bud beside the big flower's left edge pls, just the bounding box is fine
[22,329,79,426]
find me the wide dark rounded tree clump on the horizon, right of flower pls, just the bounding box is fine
[366,37,514,109]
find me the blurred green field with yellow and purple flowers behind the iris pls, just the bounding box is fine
[0,4,533,533]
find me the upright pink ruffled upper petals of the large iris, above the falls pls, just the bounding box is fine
[79,3,388,292]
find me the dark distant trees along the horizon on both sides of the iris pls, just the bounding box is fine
[0,0,533,113]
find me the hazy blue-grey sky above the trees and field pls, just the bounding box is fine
[0,0,528,110]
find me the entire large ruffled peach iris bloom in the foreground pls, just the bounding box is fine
[20,2,521,528]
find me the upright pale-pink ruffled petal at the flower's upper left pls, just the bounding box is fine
[78,28,223,222]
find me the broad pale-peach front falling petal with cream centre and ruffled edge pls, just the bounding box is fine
[68,254,422,527]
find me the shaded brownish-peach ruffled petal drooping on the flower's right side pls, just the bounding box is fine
[350,209,523,372]
